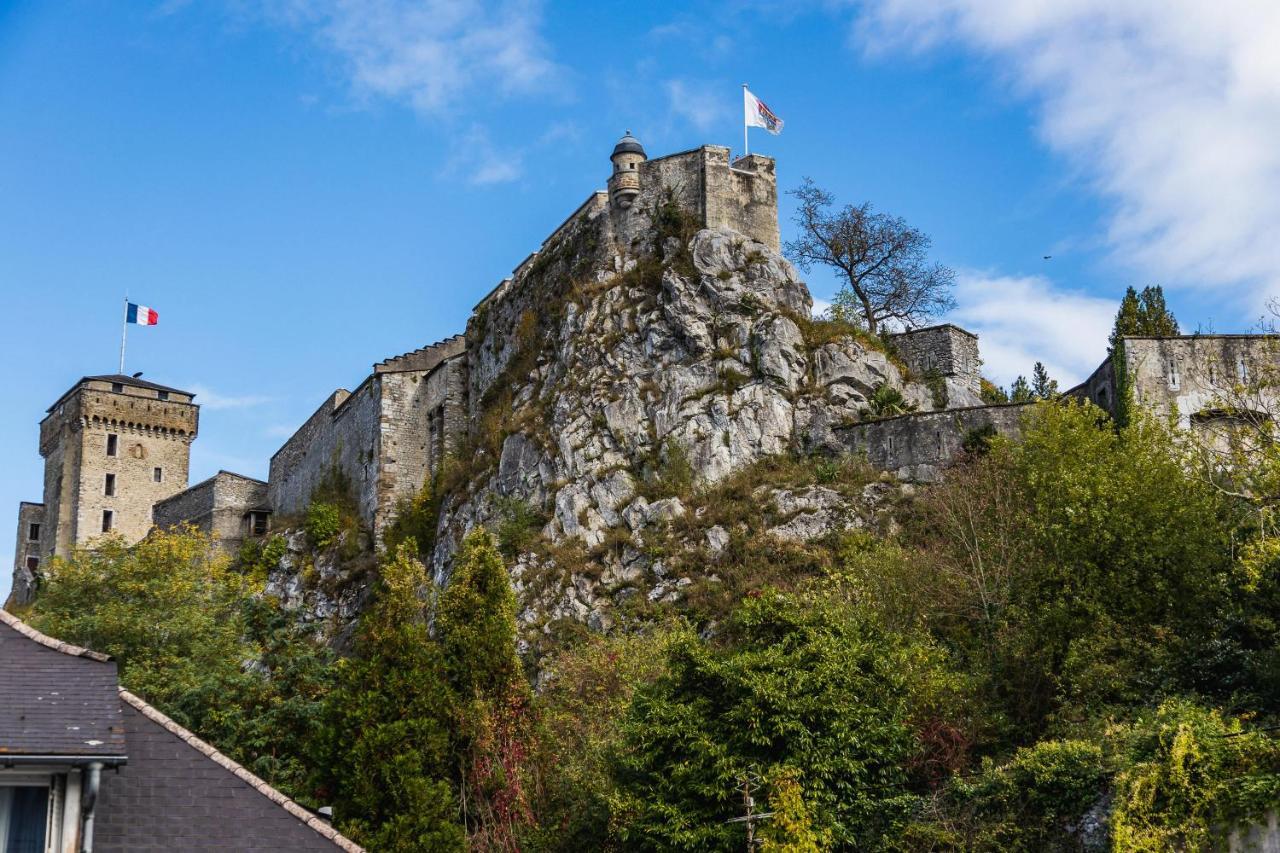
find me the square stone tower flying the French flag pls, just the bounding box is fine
[13,375,200,603]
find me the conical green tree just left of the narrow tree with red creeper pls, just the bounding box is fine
[320,542,466,852]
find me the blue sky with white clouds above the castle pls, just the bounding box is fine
[0,0,1280,596]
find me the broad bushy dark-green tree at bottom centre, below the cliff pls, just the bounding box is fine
[613,590,915,850]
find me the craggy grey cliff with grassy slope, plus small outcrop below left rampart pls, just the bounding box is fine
[259,215,937,646]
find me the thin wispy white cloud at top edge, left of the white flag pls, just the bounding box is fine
[262,0,563,113]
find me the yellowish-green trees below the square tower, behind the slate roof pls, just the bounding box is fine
[31,528,332,803]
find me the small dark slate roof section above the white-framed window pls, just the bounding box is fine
[0,610,125,763]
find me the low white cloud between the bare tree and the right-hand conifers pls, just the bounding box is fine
[947,272,1116,389]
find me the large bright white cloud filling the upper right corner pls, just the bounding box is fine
[855,0,1280,313]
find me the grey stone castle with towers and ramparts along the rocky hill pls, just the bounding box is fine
[10,132,1276,605]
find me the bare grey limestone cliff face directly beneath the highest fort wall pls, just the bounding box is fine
[431,219,933,645]
